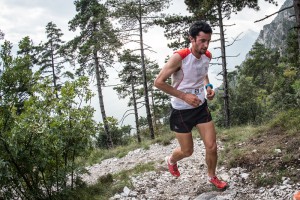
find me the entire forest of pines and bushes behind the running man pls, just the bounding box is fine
[0,0,300,199]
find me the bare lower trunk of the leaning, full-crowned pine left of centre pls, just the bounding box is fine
[94,52,114,148]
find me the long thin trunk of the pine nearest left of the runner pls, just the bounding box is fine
[139,0,155,139]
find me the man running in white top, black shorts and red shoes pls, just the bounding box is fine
[154,21,227,189]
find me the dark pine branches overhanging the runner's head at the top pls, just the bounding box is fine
[155,0,277,50]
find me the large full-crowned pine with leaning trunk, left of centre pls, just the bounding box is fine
[65,0,121,148]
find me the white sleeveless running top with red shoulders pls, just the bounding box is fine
[171,48,211,110]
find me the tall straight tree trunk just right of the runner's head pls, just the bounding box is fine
[218,5,230,127]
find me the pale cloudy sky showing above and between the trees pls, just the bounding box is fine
[0,0,285,126]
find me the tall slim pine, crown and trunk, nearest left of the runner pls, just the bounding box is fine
[108,0,169,139]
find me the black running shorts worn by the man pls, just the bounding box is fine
[170,100,212,133]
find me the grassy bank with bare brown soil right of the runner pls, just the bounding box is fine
[218,109,300,187]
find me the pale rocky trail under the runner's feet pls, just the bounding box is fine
[83,139,300,200]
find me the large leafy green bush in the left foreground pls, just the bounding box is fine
[0,48,96,199]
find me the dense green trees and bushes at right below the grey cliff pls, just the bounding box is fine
[213,28,300,126]
